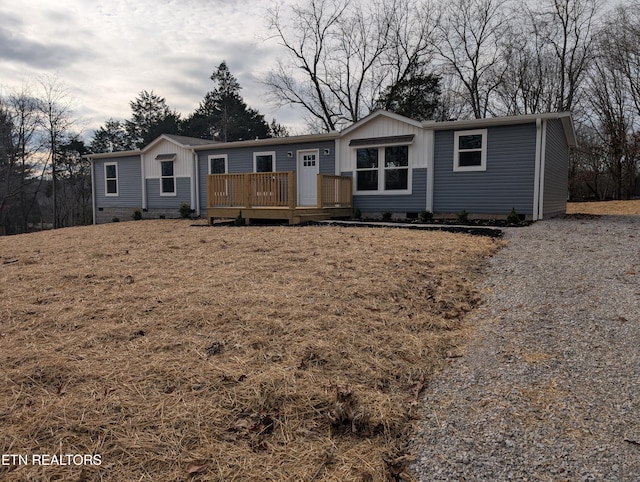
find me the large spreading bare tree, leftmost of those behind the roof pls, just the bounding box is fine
[265,0,437,131]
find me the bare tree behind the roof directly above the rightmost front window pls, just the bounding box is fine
[436,0,508,119]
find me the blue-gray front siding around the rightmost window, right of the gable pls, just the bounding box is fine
[433,123,536,215]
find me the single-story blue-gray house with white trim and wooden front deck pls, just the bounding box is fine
[87,111,576,223]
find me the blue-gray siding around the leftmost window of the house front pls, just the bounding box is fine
[93,156,142,208]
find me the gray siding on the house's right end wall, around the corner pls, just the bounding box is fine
[542,119,569,218]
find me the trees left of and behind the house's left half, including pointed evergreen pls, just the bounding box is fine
[0,62,287,235]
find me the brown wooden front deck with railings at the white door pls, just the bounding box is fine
[207,172,353,224]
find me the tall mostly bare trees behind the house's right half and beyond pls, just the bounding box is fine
[266,0,640,199]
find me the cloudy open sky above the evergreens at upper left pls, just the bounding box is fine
[0,0,303,138]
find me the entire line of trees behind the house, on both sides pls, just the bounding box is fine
[0,0,640,234]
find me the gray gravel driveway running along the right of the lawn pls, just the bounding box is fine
[412,216,640,481]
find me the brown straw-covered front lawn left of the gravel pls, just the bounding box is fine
[0,221,500,481]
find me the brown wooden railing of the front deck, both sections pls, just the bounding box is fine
[207,171,352,209]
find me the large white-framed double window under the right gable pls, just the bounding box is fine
[356,146,409,192]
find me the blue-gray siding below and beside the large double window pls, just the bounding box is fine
[342,169,427,213]
